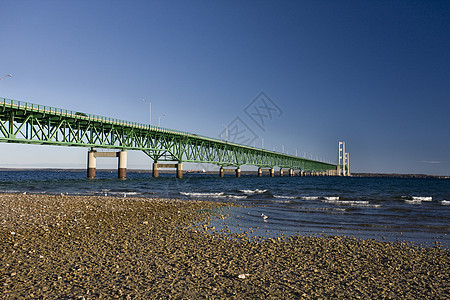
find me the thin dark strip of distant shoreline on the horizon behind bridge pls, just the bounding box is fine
[0,168,450,179]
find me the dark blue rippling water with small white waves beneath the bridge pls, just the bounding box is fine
[0,171,450,248]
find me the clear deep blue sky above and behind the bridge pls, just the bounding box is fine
[0,0,450,175]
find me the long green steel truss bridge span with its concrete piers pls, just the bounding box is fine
[0,98,337,178]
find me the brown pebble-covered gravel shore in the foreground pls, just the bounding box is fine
[0,195,450,299]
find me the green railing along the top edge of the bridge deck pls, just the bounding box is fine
[0,98,334,164]
